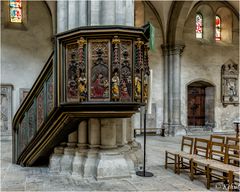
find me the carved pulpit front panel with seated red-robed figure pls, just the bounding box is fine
[89,40,110,101]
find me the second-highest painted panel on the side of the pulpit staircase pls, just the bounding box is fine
[37,89,44,129]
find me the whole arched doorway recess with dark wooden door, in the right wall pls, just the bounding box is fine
[187,81,215,127]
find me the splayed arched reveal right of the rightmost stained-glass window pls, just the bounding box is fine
[216,7,233,43]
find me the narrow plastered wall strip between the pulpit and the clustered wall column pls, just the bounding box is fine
[134,2,163,128]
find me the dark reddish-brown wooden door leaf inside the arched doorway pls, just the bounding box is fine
[188,87,205,126]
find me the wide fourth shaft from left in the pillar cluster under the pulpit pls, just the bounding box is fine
[100,119,118,148]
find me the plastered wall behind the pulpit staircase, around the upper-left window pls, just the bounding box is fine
[1,1,53,115]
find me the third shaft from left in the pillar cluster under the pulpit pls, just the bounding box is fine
[88,118,101,148]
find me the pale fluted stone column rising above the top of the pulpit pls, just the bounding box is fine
[57,0,134,30]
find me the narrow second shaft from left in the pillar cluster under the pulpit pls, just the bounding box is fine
[77,121,88,148]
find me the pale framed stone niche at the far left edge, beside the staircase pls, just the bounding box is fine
[0,85,13,135]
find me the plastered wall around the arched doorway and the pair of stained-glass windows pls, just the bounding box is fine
[181,2,239,131]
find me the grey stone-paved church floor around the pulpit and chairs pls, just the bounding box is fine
[1,136,235,191]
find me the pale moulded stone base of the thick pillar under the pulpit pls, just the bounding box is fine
[49,141,143,180]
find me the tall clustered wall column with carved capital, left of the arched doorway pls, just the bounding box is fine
[162,45,184,136]
